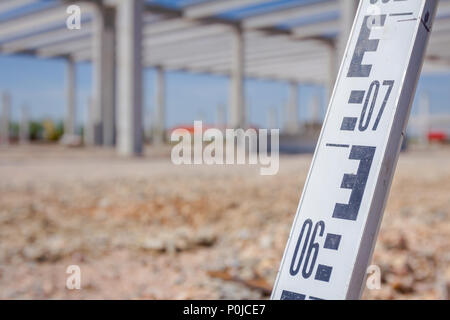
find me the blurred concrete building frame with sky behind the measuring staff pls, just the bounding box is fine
[0,0,450,155]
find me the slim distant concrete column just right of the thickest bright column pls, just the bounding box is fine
[153,66,166,145]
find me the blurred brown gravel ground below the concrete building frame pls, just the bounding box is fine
[0,146,450,299]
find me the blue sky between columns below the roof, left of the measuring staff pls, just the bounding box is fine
[0,56,324,127]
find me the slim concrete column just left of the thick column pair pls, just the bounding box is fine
[64,58,76,137]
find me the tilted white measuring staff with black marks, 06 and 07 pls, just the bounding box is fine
[272,0,437,300]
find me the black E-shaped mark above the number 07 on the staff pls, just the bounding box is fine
[347,14,386,78]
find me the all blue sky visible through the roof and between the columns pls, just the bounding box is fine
[0,0,450,131]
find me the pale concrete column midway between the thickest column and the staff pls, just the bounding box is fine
[229,27,246,128]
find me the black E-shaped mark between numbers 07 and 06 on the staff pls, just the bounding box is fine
[333,146,376,221]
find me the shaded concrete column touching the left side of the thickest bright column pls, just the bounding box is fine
[92,1,115,146]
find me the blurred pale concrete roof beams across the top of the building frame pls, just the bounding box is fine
[0,0,450,79]
